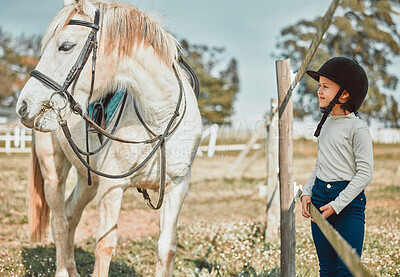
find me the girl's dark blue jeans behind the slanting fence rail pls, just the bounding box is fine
[311,178,366,276]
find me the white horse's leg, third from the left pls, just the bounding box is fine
[92,184,124,277]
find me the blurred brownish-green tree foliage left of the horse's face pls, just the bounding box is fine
[0,28,41,100]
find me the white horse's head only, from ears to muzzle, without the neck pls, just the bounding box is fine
[17,0,100,131]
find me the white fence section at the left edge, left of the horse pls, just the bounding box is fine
[0,123,32,153]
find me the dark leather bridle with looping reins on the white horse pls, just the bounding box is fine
[30,10,189,209]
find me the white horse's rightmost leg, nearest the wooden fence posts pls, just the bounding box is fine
[157,171,190,276]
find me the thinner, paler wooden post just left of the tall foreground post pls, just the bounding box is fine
[265,98,280,239]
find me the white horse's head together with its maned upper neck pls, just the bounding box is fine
[17,0,177,131]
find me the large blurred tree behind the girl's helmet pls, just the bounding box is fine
[277,0,400,126]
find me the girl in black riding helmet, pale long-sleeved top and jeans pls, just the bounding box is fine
[301,57,373,276]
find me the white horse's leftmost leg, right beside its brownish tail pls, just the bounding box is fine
[35,132,71,277]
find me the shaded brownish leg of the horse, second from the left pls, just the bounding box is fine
[65,173,98,277]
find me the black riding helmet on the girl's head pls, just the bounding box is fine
[306,57,368,112]
